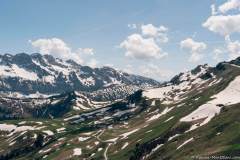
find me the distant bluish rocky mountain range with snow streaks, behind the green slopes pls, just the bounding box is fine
[0,53,159,99]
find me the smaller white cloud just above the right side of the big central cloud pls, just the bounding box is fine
[141,24,168,43]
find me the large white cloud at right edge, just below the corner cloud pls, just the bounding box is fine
[203,14,240,36]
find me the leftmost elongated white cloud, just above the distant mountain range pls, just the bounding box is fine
[29,38,94,64]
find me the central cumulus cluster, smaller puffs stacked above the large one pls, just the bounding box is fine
[120,24,168,59]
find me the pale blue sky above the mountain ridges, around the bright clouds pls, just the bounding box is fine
[0,0,240,80]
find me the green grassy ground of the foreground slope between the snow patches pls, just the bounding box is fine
[0,66,240,160]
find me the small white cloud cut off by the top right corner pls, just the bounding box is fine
[218,0,240,13]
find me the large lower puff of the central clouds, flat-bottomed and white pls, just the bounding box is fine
[120,34,167,59]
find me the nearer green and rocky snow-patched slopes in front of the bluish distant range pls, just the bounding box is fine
[0,58,240,160]
